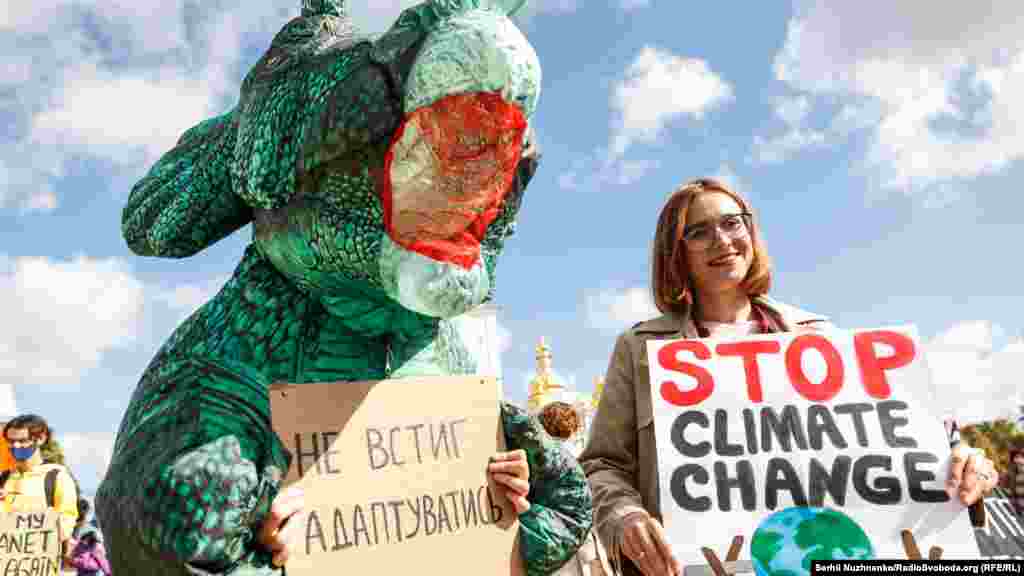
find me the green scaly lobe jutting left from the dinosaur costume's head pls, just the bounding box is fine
[121,111,253,258]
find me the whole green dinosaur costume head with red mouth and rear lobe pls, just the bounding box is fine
[122,0,541,318]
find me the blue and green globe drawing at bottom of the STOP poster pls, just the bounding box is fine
[751,507,874,576]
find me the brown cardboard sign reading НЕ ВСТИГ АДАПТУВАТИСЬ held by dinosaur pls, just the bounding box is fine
[270,376,522,576]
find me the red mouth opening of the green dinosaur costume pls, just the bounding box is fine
[380,92,526,269]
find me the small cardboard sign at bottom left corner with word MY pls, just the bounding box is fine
[0,510,60,576]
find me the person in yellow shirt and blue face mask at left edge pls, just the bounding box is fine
[0,414,78,563]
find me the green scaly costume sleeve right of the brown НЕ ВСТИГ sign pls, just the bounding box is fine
[502,403,593,576]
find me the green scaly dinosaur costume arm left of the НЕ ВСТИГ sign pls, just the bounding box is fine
[96,357,288,575]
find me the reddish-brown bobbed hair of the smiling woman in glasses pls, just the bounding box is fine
[650,178,771,316]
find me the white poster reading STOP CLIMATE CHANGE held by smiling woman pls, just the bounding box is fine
[647,327,979,564]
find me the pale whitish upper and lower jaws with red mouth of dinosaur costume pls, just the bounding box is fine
[379,0,541,317]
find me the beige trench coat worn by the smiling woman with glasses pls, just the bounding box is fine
[579,296,830,576]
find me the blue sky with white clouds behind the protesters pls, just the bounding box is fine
[0,0,1024,491]
